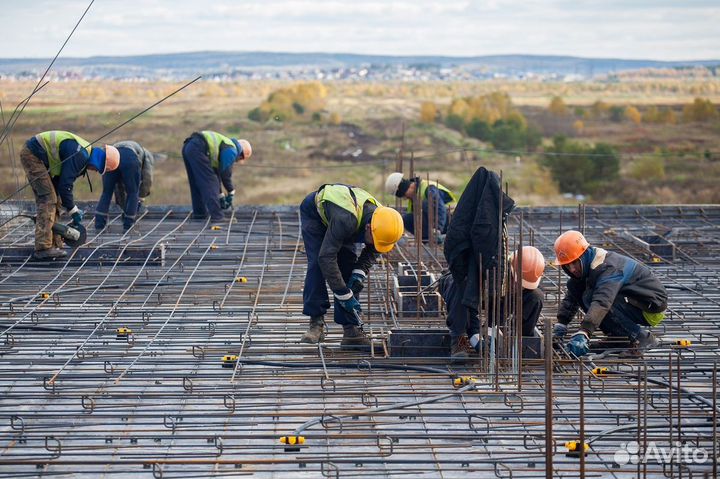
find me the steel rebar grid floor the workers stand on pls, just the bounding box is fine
[0,202,720,478]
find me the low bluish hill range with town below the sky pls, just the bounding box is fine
[0,51,720,79]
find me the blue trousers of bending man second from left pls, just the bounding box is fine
[95,147,142,230]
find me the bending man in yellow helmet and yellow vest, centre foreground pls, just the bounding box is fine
[300,184,403,349]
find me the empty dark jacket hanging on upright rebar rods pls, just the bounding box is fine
[443,167,515,308]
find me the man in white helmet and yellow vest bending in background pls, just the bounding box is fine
[385,172,457,243]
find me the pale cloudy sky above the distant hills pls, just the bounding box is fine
[0,0,720,60]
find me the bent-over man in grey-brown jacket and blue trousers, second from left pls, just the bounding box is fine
[95,140,154,231]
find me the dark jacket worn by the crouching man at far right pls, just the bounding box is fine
[557,247,667,334]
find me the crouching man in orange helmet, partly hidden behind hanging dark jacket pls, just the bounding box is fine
[439,246,545,361]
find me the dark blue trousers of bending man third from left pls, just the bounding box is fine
[182,136,224,221]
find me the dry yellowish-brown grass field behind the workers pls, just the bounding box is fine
[0,79,720,205]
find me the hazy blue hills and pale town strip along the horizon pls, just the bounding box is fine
[0,52,720,82]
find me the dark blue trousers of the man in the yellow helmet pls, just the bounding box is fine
[300,192,357,326]
